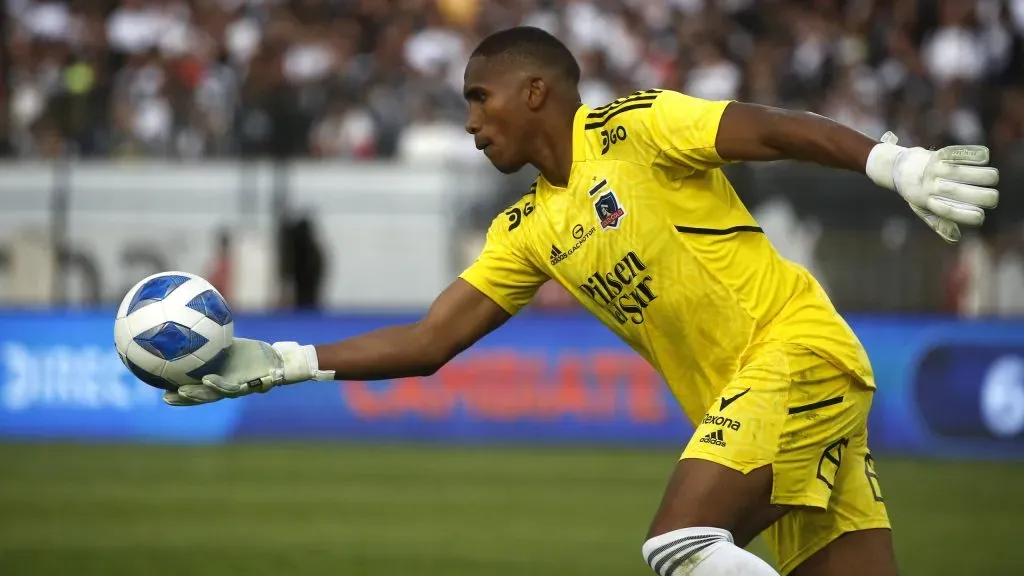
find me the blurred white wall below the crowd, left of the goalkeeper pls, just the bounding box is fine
[0,162,497,308]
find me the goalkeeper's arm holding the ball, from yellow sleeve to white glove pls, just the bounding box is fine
[164,194,548,406]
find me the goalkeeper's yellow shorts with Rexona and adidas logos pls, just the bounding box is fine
[682,345,890,574]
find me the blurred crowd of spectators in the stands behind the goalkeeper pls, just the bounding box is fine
[6,0,1024,162]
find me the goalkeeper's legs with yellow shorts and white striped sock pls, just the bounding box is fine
[643,345,896,576]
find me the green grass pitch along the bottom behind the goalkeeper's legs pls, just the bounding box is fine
[0,444,1024,576]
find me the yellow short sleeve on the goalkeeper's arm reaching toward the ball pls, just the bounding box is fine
[459,208,548,315]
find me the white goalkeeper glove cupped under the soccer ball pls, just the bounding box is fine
[164,338,334,406]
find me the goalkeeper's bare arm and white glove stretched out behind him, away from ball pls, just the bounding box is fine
[715,102,999,243]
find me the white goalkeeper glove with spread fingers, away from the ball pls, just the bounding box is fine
[865,132,999,244]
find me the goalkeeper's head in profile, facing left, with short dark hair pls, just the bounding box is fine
[464,27,580,174]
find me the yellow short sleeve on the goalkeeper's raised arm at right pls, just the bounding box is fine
[647,90,730,176]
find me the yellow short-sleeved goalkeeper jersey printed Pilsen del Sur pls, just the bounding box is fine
[461,90,873,421]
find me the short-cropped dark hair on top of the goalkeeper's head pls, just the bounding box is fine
[472,26,580,86]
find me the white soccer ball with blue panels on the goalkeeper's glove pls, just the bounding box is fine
[114,272,234,392]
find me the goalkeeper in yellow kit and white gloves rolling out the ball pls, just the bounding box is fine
[165,28,998,576]
